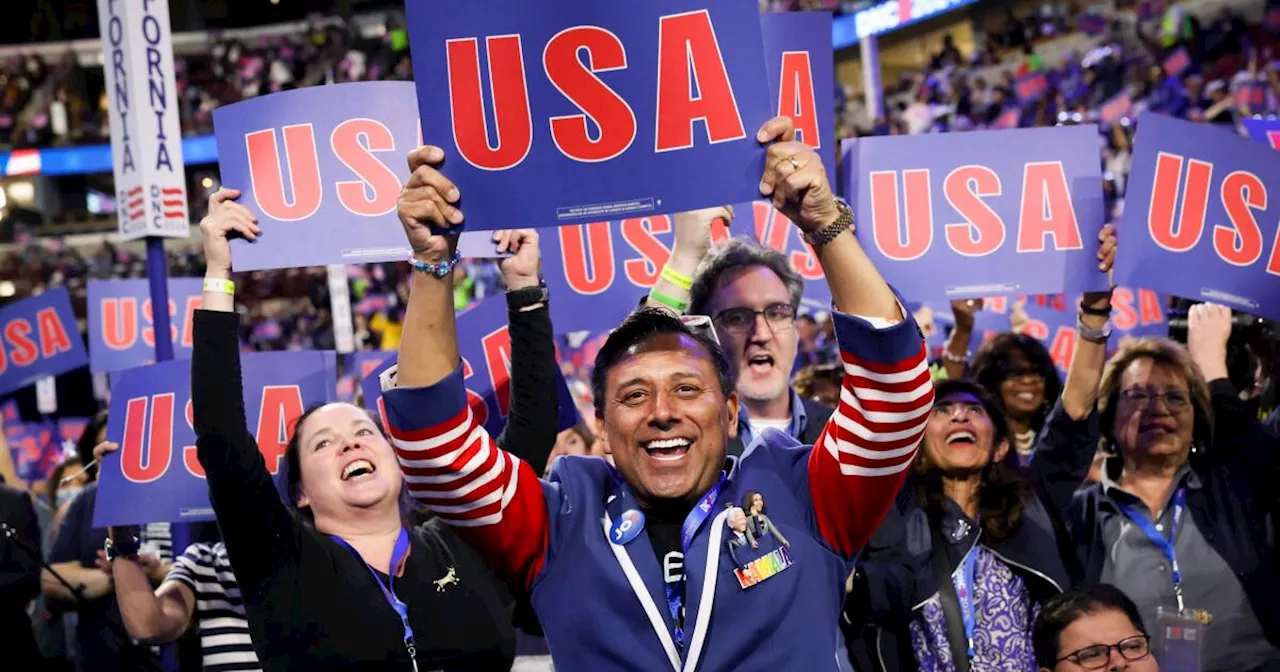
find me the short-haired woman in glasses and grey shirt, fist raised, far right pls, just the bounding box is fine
[1070,305,1280,672]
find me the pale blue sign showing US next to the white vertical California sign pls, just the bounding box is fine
[214,82,504,271]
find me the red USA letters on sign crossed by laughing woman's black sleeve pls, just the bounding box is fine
[120,385,302,483]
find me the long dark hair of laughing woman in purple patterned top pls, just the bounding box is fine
[909,380,1032,543]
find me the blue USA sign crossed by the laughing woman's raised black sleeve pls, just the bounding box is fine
[93,351,337,527]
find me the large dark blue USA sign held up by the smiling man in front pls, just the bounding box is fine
[406,0,768,229]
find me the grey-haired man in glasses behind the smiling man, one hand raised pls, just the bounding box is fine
[648,215,832,456]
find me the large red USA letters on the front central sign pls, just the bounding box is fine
[445,10,746,170]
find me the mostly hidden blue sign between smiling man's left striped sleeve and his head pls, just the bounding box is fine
[360,297,581,436]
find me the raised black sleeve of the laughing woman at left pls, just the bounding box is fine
[191,310,298,589]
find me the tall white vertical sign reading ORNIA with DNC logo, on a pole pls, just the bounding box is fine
[97,0,191,242]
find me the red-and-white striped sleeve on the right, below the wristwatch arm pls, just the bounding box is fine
[809,314,933,558]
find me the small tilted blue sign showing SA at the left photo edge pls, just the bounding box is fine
[0,287,88,396]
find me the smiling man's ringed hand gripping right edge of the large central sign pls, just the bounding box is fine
[755,116,840,232]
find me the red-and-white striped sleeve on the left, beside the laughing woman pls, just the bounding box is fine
[379,367,550,589]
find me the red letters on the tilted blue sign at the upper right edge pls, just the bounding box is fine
[1147,152,1280,275]
